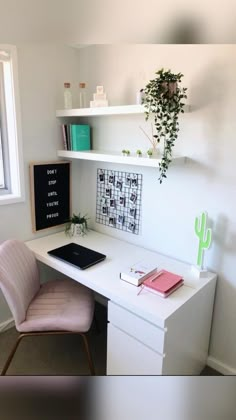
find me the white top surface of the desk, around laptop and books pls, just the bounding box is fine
[26,230,216,328]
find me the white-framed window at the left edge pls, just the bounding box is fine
[0,45,24,205]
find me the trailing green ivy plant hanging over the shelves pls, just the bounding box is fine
[141,69,187,184]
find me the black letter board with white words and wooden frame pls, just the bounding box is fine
[30,161,71,232]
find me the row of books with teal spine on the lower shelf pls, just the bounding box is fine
[61,124,91,151]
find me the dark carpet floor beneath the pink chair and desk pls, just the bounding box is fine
[0,304,219,375]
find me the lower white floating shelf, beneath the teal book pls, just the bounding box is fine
[57,150,186,168]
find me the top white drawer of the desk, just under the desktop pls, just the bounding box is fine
[108,301,165,354]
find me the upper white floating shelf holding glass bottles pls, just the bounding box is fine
[56,105,190,117]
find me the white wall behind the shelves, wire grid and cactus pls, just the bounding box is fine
[74,45,236,373]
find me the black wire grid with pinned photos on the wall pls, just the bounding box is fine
[96,168,142,235]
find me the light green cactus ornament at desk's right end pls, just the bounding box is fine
[195,212,211,267]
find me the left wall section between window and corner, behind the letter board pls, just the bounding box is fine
[0,44,81,330]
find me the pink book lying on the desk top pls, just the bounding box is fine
[143,270,183,295]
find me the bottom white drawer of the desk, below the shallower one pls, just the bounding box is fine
[107,324,163,375]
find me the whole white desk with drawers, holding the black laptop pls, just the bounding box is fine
[26,231,216,375]
